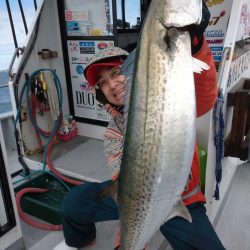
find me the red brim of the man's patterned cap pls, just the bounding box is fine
[85,58,122,86]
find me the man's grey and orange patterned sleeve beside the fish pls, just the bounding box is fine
[104,114,123,180]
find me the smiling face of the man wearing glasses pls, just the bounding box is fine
[96,66,125,106]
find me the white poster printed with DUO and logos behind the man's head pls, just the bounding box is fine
[67,40,114,121]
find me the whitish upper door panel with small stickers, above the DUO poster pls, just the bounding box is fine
[65,0,113,36]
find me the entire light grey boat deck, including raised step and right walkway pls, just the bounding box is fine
[8,137,250,250]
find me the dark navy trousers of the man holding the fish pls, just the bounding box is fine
[61,181,225,250]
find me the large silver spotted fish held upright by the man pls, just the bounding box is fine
[118,0,202,250]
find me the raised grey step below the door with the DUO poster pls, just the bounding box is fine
[26,136,111,181]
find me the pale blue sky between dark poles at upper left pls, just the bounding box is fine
[0,0,39,70]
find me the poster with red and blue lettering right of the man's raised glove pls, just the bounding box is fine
[205,0,232,62]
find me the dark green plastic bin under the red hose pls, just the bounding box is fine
[14,173,73,225]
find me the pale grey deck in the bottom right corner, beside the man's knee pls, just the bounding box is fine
[216,163,250,250]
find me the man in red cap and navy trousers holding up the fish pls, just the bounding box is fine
[55,2,224,250]
